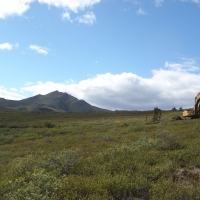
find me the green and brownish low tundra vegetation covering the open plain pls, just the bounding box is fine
[0,108,200,200]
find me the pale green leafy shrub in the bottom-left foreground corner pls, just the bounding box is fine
[2,169,62,200]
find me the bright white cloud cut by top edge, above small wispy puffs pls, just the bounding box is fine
[38,0,101,13]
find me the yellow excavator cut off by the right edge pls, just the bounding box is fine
[183,92,200,119]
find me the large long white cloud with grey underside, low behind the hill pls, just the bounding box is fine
[17,59,200,110]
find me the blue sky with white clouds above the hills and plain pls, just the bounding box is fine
[0,0,200,110]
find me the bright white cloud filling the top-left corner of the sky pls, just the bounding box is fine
[0,0,34,18]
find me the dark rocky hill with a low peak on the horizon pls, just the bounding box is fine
[0,91,109,112]
